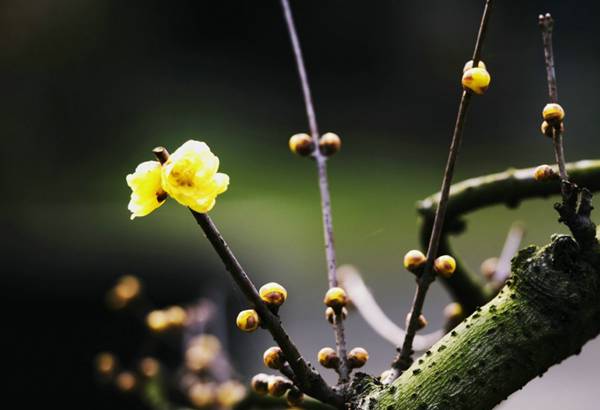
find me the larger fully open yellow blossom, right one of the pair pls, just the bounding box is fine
[162,140,229,213]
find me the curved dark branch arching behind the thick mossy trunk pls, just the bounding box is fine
[417,160,600,313]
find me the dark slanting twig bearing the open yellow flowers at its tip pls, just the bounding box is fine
[153,147,342,406]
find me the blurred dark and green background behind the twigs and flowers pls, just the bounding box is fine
[0,0,600,410]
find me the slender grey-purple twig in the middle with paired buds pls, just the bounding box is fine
[281,0,350,383]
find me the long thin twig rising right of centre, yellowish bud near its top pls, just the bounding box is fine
[390,0,493,380]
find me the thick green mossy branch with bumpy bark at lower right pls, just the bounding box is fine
[350,235,600,410]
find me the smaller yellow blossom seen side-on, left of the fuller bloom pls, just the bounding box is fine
[126,161,167,219]
